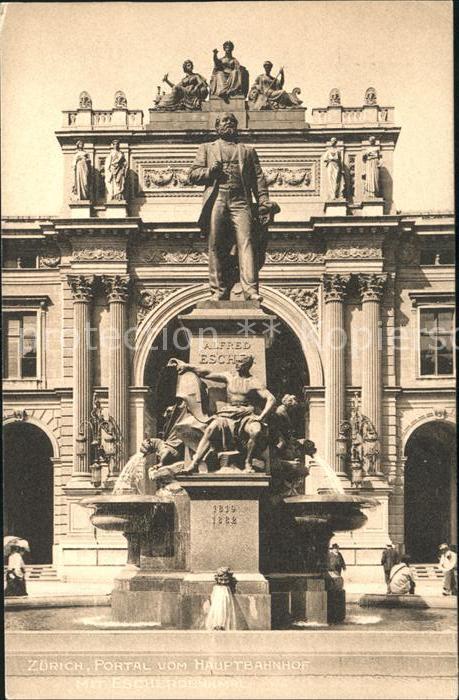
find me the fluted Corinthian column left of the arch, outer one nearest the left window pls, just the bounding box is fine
[67,275,94,487]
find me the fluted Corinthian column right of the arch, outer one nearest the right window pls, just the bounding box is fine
[358,274,387,473]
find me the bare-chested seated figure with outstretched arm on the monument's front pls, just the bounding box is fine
[169,355,276,472]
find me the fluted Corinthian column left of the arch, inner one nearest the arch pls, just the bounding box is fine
[102,275,130,472]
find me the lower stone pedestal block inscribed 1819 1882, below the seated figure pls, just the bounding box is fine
[179,470,271,630]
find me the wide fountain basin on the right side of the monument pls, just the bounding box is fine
[284,493,378,533]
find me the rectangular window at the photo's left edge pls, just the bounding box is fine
[3,313,37,379]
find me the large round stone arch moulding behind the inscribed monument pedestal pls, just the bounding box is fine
[133,284,324,387]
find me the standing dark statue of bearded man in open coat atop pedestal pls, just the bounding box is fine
[188,112,280,301]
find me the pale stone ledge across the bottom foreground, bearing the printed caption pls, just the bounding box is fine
[6,630,457,700]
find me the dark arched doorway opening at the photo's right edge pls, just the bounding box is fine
[405,421,456,563]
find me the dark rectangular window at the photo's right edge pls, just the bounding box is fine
[419,308,455,376]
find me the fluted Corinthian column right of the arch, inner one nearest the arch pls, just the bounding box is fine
[323,275,350,476]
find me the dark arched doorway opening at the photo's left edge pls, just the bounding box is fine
[3,421,53,564]
